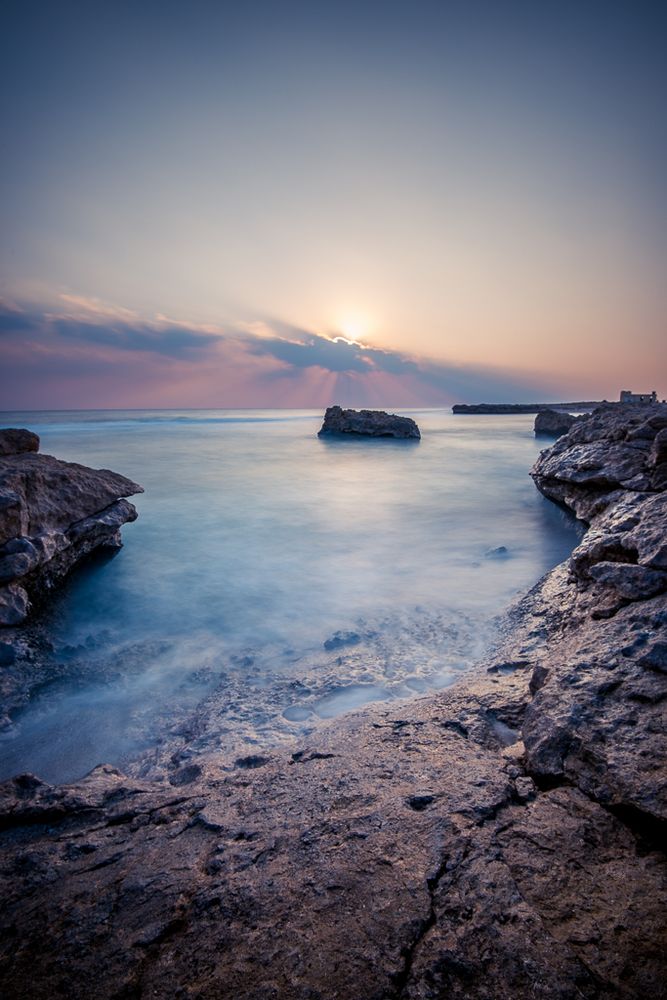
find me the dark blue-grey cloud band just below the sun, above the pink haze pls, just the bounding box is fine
[0,304,544,405]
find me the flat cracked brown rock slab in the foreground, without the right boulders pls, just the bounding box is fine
[0,612,667,1000]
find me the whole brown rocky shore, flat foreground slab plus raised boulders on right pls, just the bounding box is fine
[0,405,667,1000]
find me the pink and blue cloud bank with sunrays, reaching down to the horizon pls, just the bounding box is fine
[0,295,564,409]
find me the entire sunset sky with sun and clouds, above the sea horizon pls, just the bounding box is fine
[0,0,667,409]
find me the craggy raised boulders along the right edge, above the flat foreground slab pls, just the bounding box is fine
[523,404,667,824]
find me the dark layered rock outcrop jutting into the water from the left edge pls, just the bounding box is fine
[0,428,143,626]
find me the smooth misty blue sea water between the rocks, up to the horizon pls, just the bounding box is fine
[0,410,577,781]
